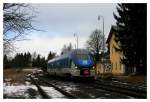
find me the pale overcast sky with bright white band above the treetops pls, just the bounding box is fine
[16,3,116,57]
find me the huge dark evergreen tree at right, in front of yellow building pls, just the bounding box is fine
[114,3,147,74]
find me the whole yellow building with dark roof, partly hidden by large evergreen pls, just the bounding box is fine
[106,26,126,75]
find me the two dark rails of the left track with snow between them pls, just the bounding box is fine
[30,76,77,99]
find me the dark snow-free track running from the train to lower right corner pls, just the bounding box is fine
[43,75,147,99]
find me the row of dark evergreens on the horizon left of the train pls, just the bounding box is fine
[3,52,50,71]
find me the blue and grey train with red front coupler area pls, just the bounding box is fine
[47,49,95,78]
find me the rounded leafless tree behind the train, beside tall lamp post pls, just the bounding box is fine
[86,29,103,61]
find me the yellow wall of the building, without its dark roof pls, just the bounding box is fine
[109,34,125,75]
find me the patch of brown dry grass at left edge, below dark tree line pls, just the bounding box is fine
[4,69,32,83]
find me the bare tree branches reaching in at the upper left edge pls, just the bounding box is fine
[3,3,36,54]
